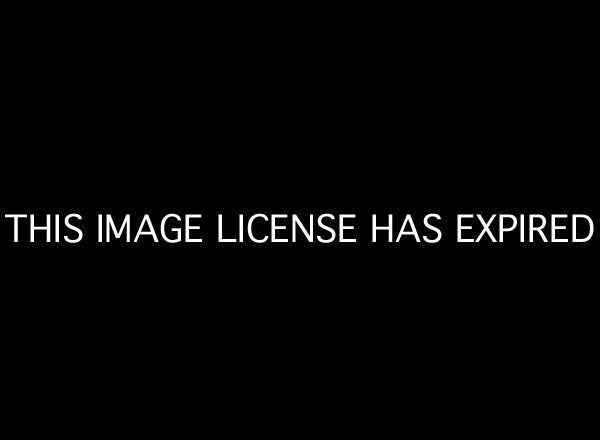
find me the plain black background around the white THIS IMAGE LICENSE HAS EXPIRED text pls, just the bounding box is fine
[1,5,598,433]
